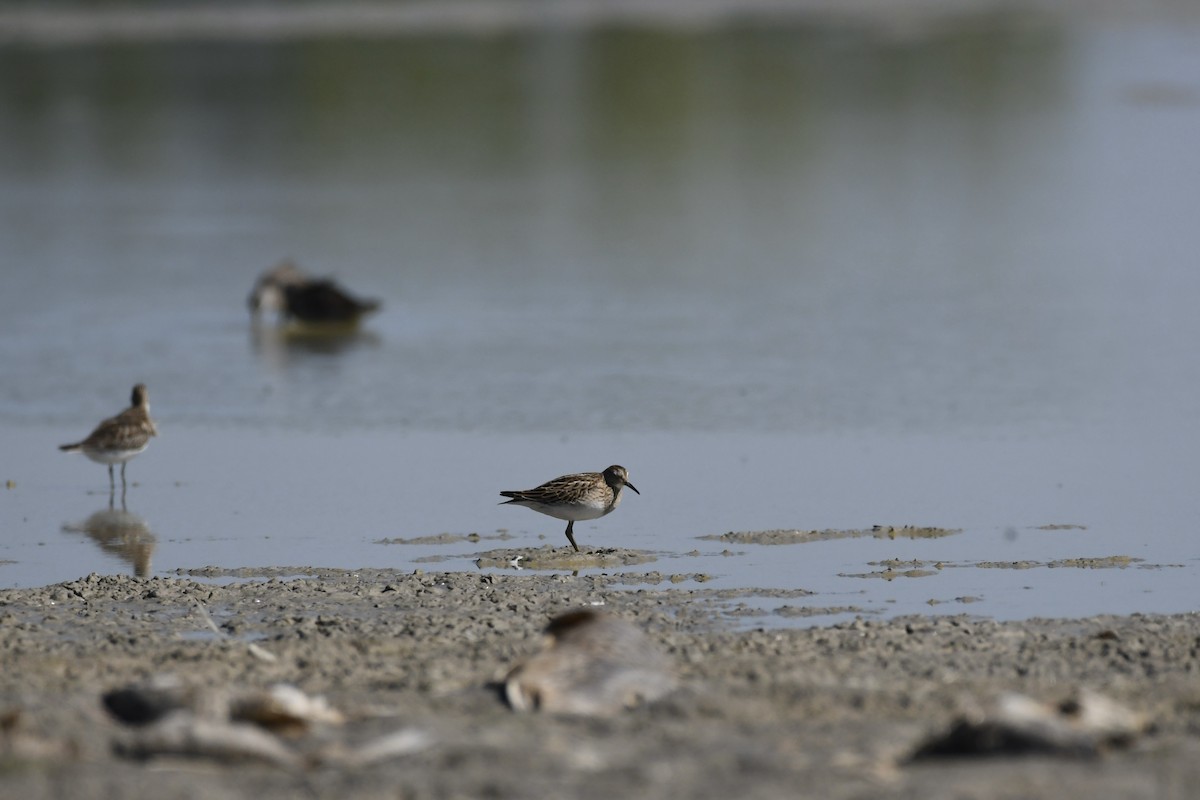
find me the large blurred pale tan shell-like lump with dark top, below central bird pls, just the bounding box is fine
[504,609,676,715]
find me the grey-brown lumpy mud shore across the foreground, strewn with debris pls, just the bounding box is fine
[0,567,1200,799]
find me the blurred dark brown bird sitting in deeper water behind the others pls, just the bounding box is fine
[247,260,379,325]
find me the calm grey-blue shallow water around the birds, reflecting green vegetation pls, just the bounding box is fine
[0,10,1200,624]
